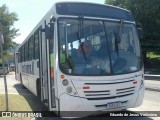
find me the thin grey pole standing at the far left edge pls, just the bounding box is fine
[0,31,8,111]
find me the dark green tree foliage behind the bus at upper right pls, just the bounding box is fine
[105,0,160,54]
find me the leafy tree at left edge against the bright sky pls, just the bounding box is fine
[0,5,19,51]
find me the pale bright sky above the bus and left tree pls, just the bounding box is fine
[0,0,105,43]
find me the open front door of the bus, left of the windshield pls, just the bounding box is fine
[40,21,56,111]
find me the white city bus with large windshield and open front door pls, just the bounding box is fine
[15,2,144,116]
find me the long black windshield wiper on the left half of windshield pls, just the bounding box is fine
[77,16,87,61]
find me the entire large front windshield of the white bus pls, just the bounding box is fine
[58,18,142,75]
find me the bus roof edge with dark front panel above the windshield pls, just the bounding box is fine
[17,1,134,50]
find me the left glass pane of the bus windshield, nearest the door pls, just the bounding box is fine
[59,19,110,75]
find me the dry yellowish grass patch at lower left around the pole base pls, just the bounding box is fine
[0,94,39,120]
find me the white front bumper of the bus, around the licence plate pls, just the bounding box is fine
[60,86,144,117]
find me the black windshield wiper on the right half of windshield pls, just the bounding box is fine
[114,20,124,55]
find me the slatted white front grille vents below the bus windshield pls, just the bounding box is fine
[83,80,136,100]
